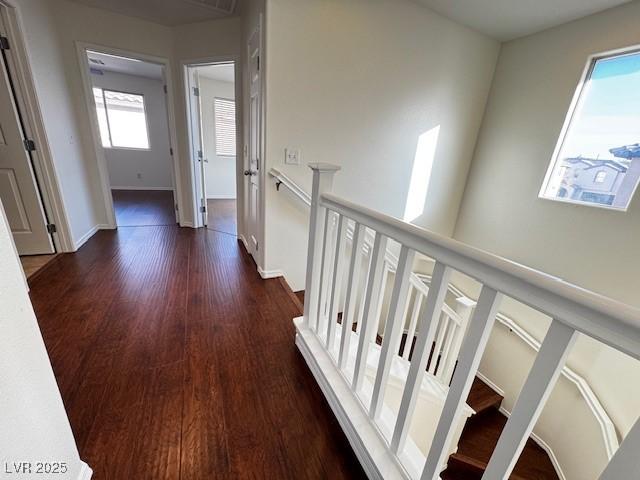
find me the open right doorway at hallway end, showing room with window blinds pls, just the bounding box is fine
[185,62,238,235]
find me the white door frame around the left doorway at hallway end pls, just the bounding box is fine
[75,41,184,229]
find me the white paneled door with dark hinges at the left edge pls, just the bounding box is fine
[0,37,55,255]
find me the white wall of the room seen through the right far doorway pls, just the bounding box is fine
[200,75,236,199]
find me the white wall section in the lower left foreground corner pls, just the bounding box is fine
[0,200,88,480]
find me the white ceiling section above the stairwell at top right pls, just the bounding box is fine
[415,0,632,41]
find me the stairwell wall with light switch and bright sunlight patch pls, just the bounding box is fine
[265,0,499,289]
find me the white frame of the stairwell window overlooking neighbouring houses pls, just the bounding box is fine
[538,45,640,212]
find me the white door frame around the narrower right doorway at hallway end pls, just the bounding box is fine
[181,55,245,231]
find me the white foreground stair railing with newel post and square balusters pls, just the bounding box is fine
[294,165,640,480]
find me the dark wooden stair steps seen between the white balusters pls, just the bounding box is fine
[441,377,558,480]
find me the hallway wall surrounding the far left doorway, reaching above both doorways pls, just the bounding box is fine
[16,0,242,242]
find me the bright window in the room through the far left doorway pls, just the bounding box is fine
[93,87,149,150]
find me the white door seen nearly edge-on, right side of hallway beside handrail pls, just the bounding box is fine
[244,26,262,257]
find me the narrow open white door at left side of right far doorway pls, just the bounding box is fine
[188,67,207,227]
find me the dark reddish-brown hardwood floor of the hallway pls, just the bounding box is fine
[30,226,365,480]
